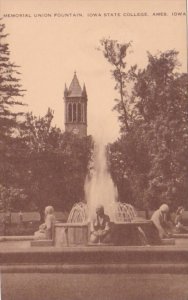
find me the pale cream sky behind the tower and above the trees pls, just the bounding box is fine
[0,0,187,142]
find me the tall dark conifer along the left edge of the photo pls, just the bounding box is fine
[0,23,24,197]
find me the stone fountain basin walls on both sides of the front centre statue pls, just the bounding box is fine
[54,220,161,247]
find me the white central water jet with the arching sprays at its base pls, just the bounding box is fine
[68,141,136,223]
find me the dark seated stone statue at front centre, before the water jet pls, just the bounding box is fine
[90,205,111,243]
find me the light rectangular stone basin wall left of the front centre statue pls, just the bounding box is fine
[54,223,88,247]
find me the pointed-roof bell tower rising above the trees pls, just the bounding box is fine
[64,72,87,137]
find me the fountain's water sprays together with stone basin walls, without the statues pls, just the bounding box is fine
[55,141,151,246]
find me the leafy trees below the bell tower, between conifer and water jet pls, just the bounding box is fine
[18,109,92,212]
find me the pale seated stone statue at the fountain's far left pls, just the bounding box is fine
[34,206,55,240]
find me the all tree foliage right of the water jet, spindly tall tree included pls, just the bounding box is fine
[103,40,188,209]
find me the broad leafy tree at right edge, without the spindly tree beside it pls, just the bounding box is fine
[134,50,188,207]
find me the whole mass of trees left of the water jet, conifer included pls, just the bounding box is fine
[0,25,93,213]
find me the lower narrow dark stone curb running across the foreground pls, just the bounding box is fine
[0,263,188,274]
